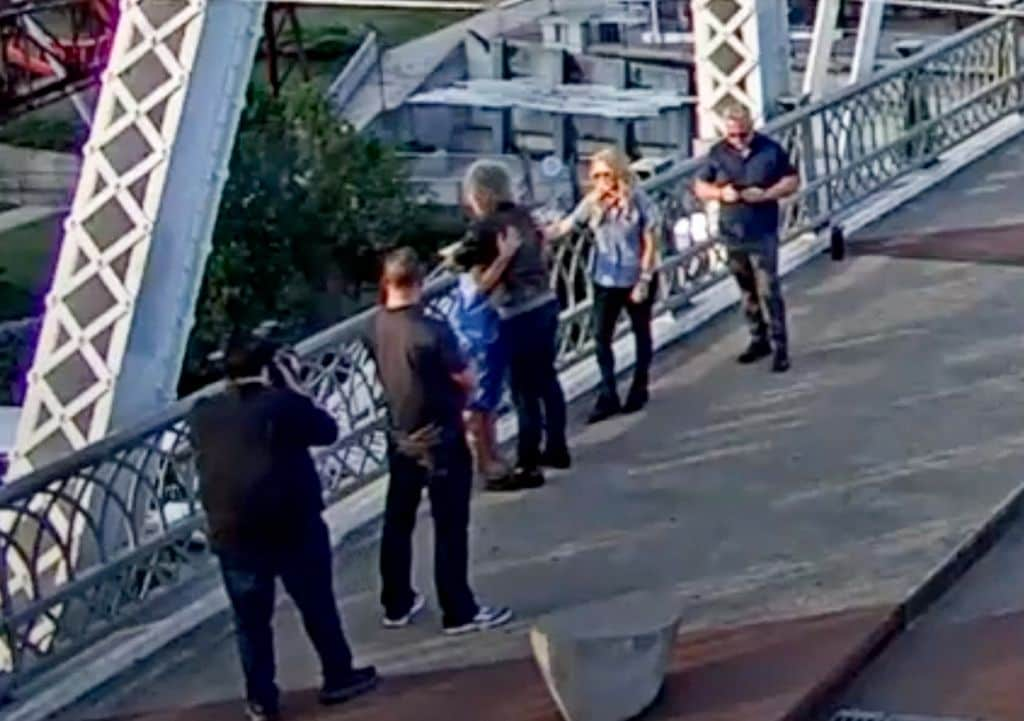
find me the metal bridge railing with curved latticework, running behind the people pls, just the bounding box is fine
[0,12,1022,687]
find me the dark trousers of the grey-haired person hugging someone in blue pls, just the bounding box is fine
[502,302,566,469]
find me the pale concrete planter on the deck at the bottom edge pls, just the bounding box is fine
[530,592,680,721]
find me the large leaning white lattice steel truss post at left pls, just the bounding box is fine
[11,0,264,477]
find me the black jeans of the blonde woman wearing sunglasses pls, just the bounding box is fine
[594,284,657,410]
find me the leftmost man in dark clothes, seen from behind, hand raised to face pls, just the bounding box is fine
[191,336,377,721]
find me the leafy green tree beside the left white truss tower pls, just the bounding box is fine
[182,86,446,390]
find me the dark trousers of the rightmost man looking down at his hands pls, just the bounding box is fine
[729,240,788,353]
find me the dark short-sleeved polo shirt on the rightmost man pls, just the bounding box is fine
[697,133,797,247]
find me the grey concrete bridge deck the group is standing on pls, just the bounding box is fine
[60,139,1024,721]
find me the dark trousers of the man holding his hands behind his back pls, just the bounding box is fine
[380,433,478,626]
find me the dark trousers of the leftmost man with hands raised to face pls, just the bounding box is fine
[218,517,352,708]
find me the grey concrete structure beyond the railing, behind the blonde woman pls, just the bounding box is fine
[358,2,693,205]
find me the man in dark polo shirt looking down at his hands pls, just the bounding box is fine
[694,105,800,373]
